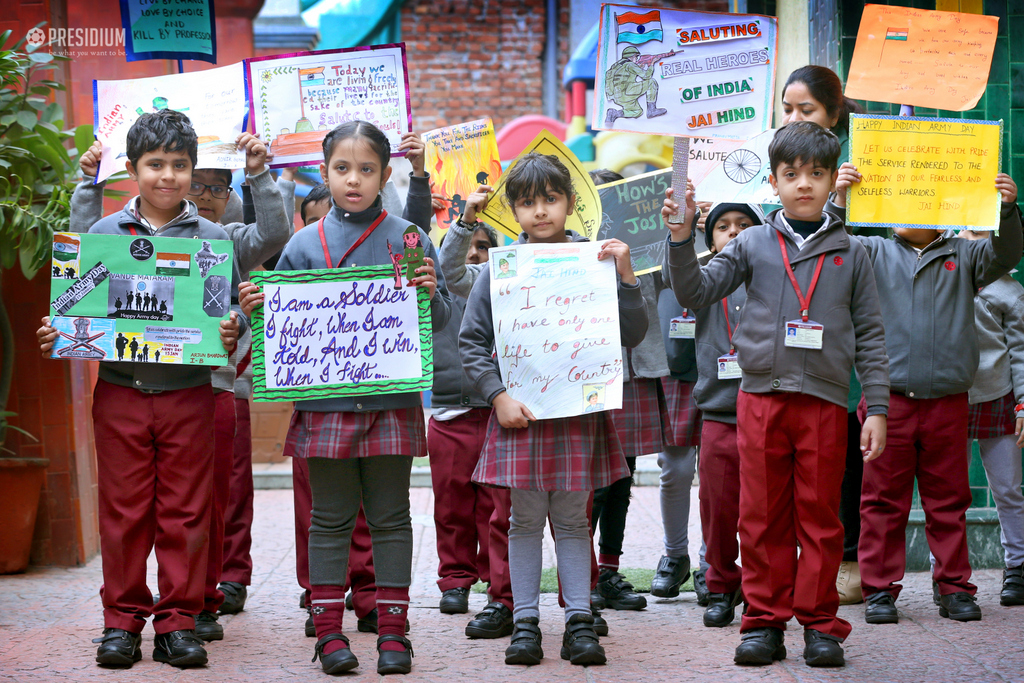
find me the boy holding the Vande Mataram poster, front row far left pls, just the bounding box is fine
[38,110,245,667]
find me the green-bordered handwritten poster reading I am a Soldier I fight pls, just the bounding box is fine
[252,265,433,401]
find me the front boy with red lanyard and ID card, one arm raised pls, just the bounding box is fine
[662,121,889,667]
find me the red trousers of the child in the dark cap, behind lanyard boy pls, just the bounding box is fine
[698,416,742,593]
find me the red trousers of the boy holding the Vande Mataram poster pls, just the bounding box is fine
[92,380,214,634]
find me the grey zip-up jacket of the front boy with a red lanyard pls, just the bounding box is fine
[667,210,889,415]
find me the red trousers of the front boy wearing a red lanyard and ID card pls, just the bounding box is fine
[737,391,847,639]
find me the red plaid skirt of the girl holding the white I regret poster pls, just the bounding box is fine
[473,411,630,490]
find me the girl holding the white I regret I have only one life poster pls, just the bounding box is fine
[459,154,647,665]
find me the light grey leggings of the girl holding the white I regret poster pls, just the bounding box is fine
[509,488,591,622]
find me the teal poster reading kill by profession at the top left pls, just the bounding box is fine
[121,0,217,65]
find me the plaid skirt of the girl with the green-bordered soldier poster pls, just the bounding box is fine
[285,405,427,460]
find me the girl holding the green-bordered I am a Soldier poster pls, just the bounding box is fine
[240,121,451,674]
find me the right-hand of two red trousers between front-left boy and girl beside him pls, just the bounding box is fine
[220,398,253,586]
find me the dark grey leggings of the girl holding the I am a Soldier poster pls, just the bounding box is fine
[307,456,413,588]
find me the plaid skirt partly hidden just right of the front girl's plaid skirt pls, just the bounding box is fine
[611,377,672,458]
